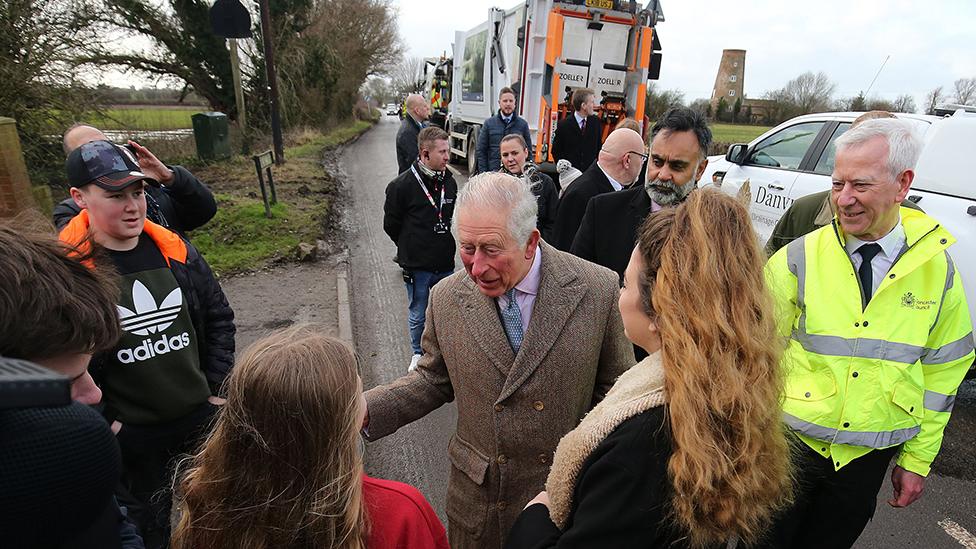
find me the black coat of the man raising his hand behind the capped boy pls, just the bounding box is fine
[54,166,217,236]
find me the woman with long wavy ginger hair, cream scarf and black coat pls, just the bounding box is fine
[507,190,792,548]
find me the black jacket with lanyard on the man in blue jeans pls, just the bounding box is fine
[383,163,457,272]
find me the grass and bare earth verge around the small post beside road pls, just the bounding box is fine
[190,121,371,276]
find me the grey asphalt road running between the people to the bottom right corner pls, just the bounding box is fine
[340,116,976,549]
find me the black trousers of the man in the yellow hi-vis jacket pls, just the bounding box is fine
[760,439,899,549]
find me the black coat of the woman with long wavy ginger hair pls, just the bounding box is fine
[505,406,720,549]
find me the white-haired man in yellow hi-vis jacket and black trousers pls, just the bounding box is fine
[766,119,973,548]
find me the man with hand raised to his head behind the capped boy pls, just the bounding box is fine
[54,124,217,236]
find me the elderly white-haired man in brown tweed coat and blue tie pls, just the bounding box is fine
[366,173,634,549]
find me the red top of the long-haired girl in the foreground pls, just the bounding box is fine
[363,475,450,549]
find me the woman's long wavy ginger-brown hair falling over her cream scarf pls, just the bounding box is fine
[638,190,792,546]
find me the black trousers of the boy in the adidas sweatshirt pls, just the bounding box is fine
[116,402,217,549]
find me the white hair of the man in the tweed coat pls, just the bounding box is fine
[451,172,539,246]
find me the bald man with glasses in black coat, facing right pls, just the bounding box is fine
[553,128,646,249]
